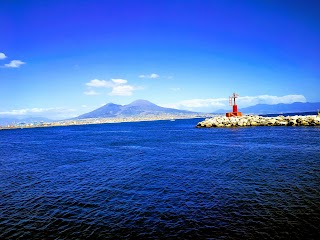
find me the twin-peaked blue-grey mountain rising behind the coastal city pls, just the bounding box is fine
[76,100,194,119]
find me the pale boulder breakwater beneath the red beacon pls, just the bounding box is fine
[197,115,320,128]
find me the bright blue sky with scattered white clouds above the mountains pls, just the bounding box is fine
[0,0,320,119]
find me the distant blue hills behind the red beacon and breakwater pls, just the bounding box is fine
[215,102,320,114]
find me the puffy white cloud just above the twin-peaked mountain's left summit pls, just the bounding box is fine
[84,78,142,96]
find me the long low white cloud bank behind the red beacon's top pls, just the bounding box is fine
[161,95,306,112]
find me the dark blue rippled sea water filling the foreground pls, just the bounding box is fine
[0,119,320,239]
